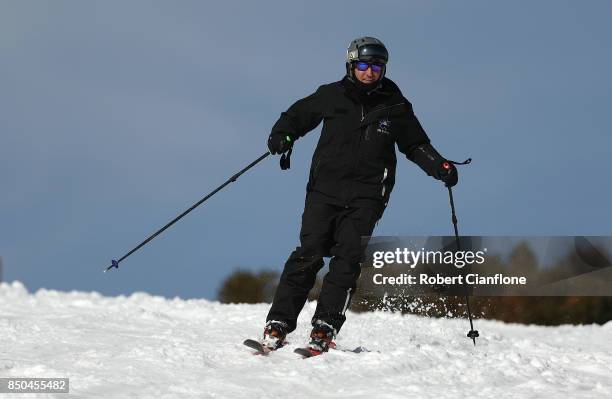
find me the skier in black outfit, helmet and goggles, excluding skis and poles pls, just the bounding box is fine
[261,37,458,355]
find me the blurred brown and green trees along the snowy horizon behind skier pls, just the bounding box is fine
[218,243,612,325]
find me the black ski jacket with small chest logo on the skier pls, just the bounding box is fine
[271,77,442,206]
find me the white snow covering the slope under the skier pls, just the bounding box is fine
[0,282,612,399]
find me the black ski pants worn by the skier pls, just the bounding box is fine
[266,199,384,331]
